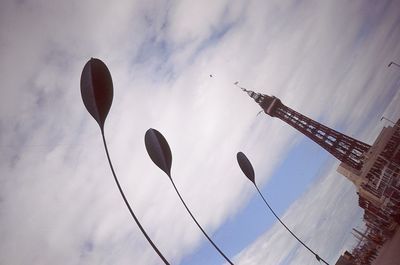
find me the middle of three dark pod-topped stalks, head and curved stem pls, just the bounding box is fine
[144,129,233,264]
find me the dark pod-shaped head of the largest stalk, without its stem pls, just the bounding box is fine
[81,58,113,131]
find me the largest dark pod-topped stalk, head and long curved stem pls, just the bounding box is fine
[81,58,169,265]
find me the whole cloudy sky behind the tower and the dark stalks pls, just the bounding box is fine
[0,0,400,265]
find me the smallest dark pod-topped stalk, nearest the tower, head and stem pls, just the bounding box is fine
[236,152,329,265]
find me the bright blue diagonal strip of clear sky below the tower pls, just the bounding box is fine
[181,137,335,265]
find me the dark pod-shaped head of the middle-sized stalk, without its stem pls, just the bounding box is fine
[144,128,172,178]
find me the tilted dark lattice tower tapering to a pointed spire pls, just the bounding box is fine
[241,87,371,171]
